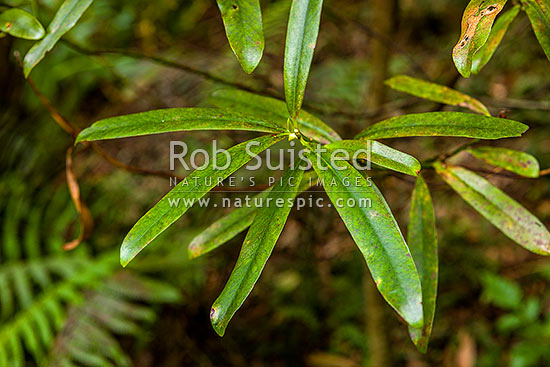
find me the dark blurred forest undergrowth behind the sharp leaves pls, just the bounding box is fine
[0,0,550,367]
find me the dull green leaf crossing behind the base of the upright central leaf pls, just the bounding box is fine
[208,89,342,144]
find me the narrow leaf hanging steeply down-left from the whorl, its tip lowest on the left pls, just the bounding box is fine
[210,168,304,336]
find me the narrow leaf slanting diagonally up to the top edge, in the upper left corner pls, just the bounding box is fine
[23,0,93,78]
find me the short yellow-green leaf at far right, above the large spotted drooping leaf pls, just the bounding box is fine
[468,147,540,178]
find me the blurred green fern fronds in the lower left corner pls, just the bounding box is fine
[0,183,180,367]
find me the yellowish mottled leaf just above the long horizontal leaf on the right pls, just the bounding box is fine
[386,75,491,116]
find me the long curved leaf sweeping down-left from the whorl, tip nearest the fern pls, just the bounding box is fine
[120,136,283,266]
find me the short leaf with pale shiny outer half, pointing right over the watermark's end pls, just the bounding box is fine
[325,140,421,176]
